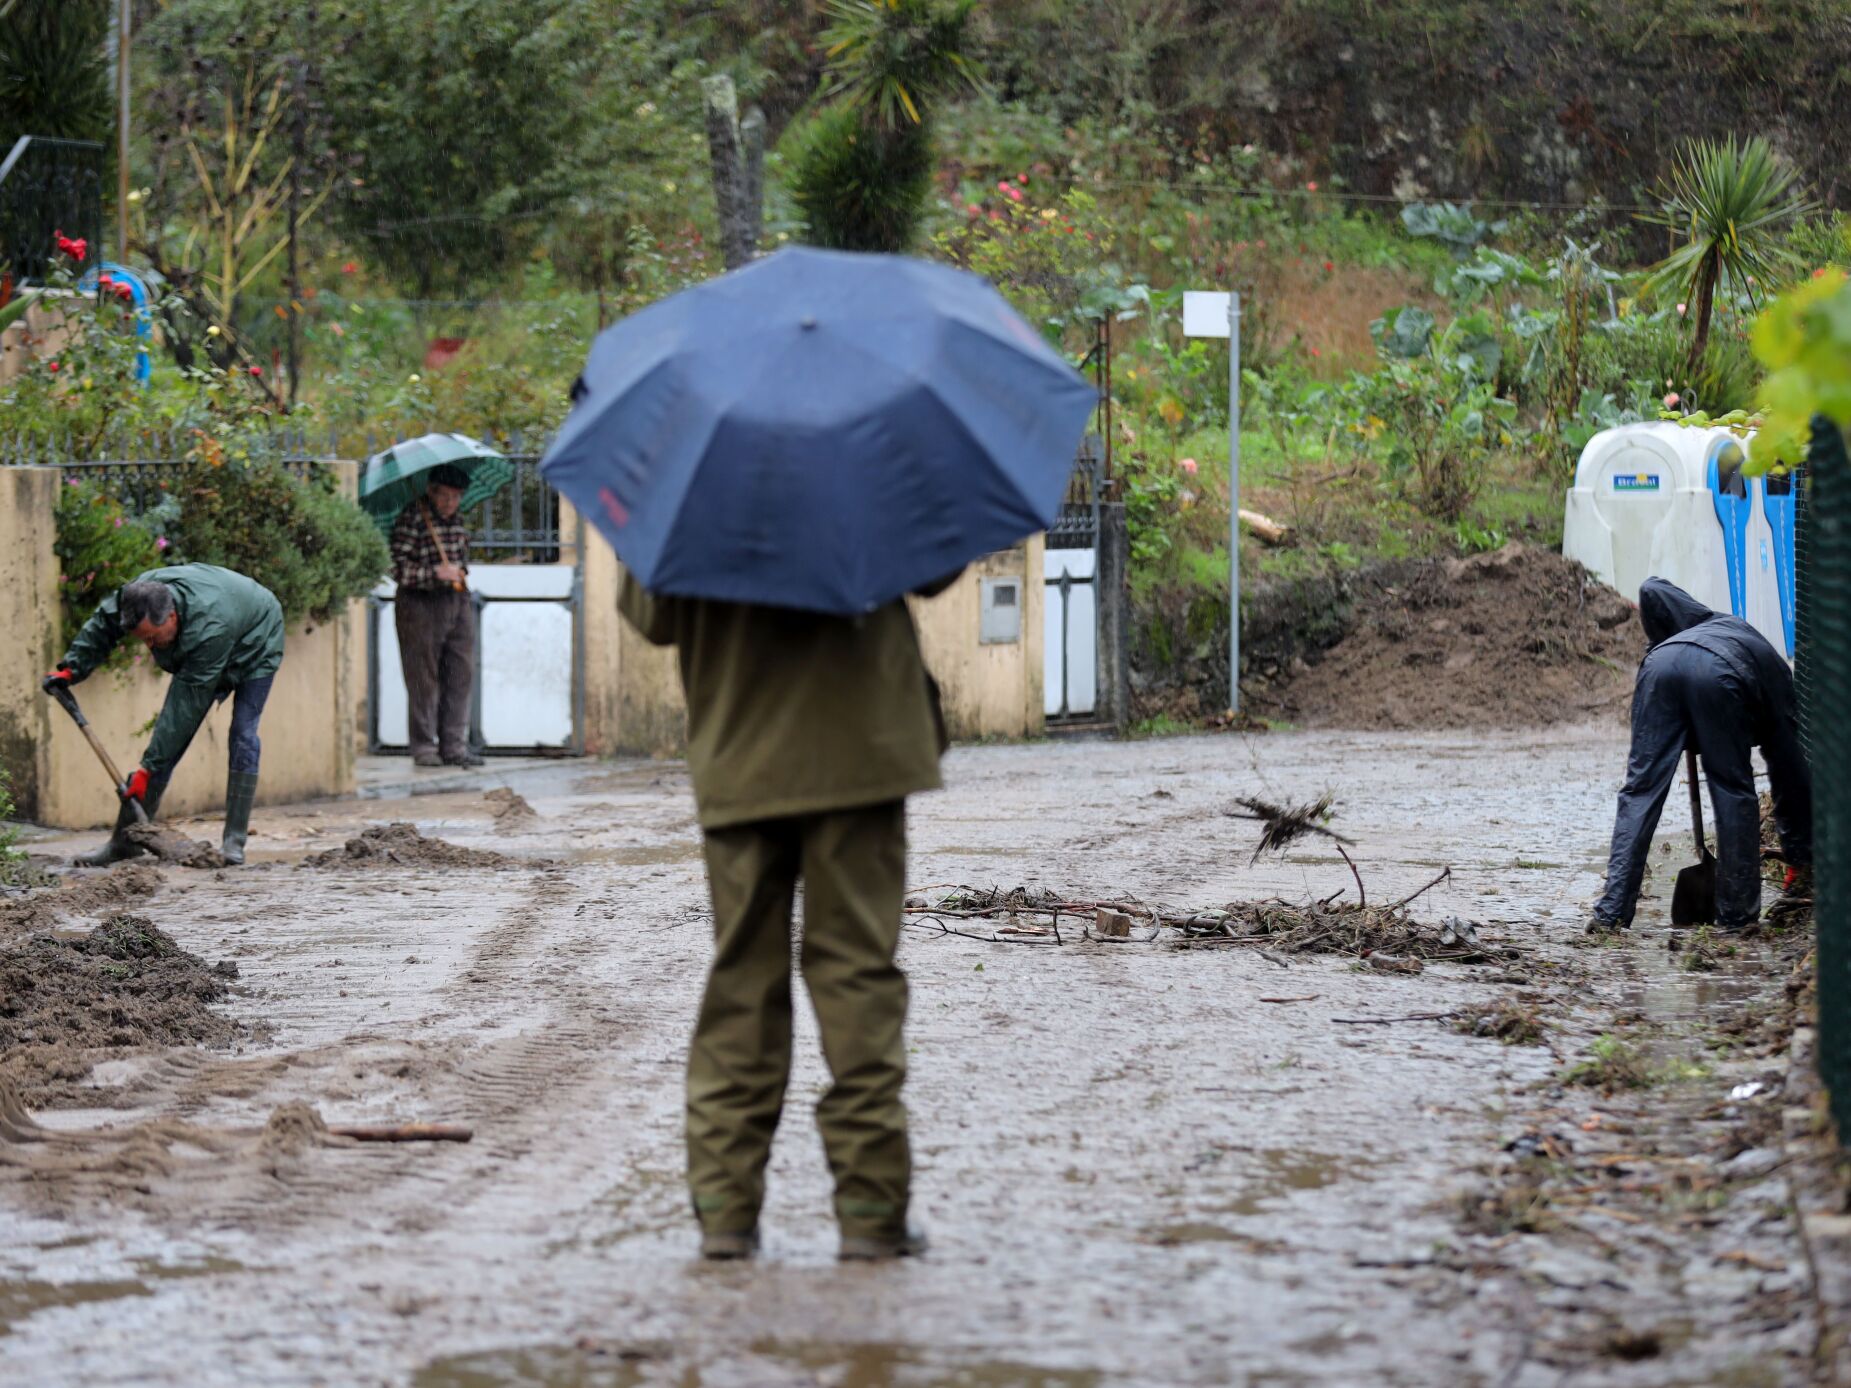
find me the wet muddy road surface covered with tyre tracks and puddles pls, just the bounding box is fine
[0,727,1816,1388]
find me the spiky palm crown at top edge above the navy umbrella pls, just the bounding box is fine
[822,0,979,130]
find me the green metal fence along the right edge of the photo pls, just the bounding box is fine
[1794,420,1851,1136]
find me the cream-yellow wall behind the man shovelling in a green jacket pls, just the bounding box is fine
[0,463,365,829]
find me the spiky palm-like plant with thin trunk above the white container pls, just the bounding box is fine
[1646,135,1814,372]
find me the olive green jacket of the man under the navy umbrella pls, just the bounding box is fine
[618,574,944,829]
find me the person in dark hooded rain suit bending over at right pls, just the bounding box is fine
[1588,577,1812,933]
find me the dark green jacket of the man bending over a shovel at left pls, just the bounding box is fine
[63,564,283,777]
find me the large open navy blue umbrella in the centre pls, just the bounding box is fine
[540,248,1098,614]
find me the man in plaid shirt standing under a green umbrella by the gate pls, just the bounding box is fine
[361,433,513,766]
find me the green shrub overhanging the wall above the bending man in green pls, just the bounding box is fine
[174,459,392,622]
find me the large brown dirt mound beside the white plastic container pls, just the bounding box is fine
[1249,544,1646,729]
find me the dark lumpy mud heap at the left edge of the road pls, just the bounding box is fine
[0,914,239,1101]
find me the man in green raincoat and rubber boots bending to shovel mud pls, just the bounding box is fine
[44,564,283,866]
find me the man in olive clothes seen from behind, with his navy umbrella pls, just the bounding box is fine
[542,250,1098,1258]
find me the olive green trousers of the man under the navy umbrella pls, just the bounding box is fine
[687,799,913,1236]
